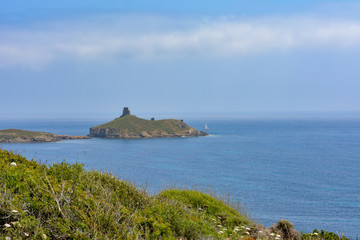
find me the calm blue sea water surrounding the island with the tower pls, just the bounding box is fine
[0,119,360,238]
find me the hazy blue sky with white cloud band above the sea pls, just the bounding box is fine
[0,0,360,119]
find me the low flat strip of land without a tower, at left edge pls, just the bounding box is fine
[0,129,90,143]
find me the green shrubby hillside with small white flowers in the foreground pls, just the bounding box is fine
[0,149,346,240]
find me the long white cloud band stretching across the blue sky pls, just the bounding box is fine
[0,17,360,68]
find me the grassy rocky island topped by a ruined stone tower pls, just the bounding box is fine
[89,107,208,139]
